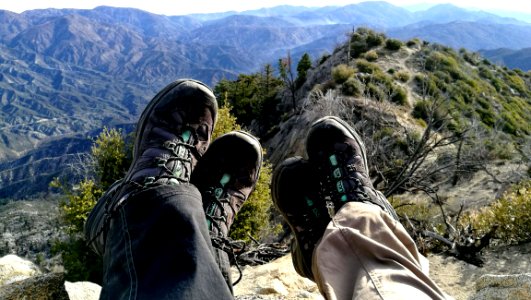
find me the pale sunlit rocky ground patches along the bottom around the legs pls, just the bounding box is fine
[0,238,531,300]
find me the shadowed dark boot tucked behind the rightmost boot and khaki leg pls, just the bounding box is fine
[271,157,330,280]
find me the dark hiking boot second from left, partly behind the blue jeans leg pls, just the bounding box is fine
[191,131,262,287]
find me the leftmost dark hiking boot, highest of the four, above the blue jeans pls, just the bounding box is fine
[85,79,217,254]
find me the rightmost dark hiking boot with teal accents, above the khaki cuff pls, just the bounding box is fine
[306,116,398,220]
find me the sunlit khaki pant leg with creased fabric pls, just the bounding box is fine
[312,202,447,300]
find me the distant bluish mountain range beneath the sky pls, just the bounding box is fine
[0,2,531,198]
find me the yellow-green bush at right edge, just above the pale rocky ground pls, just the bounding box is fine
[463,180,531,243]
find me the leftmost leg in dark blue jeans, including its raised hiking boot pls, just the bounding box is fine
[85,80,232,299]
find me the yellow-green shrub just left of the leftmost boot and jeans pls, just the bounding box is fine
[50,128,131,283]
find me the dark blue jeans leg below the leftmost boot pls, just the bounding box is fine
[85,184,233,299]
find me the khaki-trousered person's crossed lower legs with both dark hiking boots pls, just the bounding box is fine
[272,117,450,299]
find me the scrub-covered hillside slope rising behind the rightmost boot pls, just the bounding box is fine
[265,30,531,209]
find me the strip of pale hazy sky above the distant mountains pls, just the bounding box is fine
[0,0,531,15]
